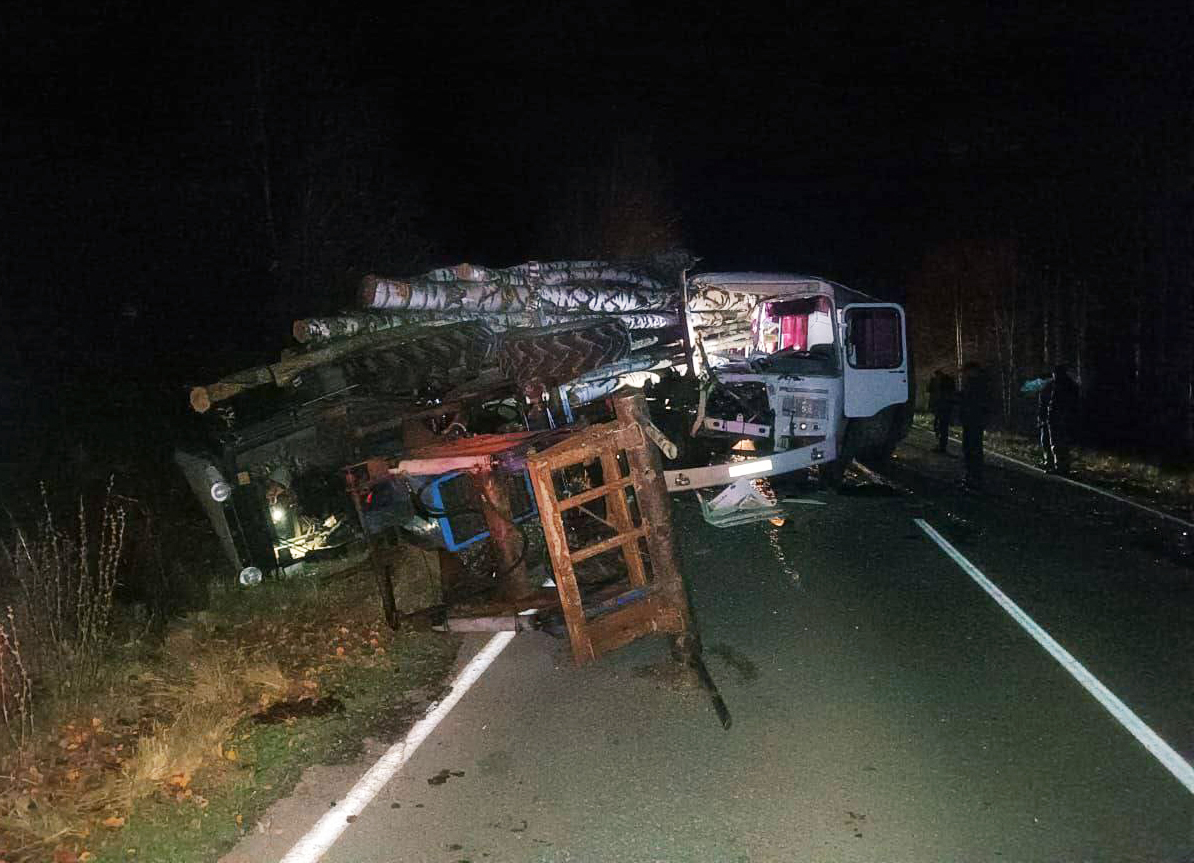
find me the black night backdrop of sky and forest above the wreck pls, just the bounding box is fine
[0,1,1194,479]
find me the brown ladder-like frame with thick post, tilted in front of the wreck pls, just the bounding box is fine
[527,395,690,665]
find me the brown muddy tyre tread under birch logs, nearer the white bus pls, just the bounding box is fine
[498,320,630,387]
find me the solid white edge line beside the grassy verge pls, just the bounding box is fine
[279,633,515,863]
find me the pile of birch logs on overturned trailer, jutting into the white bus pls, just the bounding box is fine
[191,257,756,413]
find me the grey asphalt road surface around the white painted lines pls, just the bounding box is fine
[226,434,1194,863]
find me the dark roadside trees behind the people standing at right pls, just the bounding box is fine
[909,112,1194,460]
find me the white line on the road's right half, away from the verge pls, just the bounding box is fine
[915,518,1194,794]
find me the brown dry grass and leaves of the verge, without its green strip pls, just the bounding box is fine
[0,546,434,863]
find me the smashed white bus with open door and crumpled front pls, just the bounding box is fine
[667,272,911,513]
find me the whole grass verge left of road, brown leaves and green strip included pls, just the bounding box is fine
[0,572,457,863]
